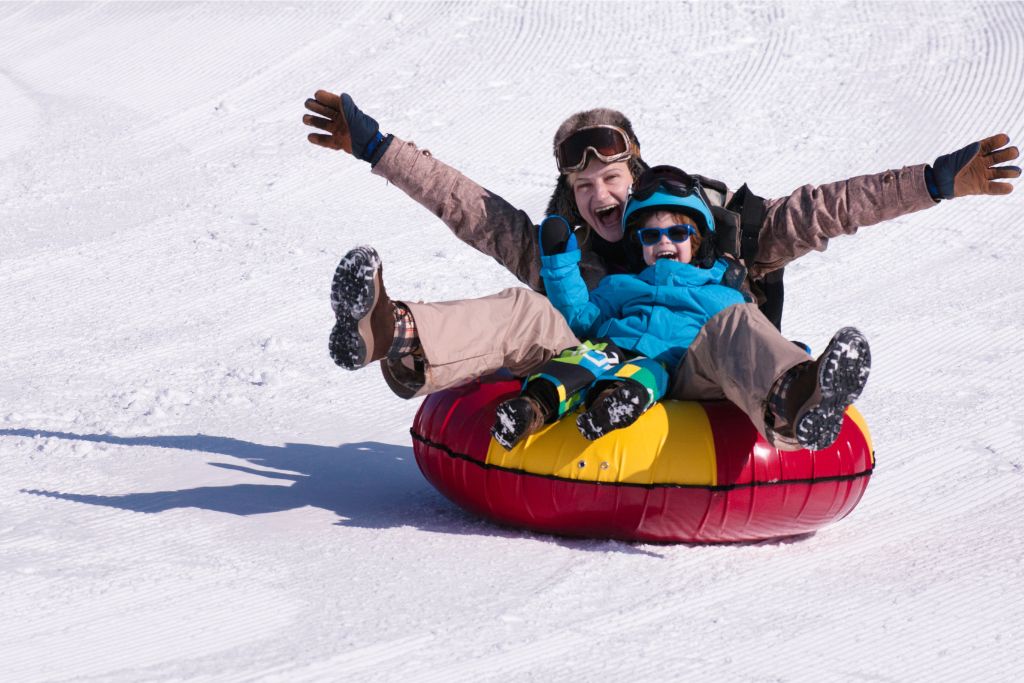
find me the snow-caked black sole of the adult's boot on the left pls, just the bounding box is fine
[328,247,382,370]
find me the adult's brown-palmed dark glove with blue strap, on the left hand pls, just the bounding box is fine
[302,90,394,165]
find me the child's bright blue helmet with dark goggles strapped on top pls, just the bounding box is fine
[623,166,715,236]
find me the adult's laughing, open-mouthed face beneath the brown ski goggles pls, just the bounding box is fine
[568,159,633,242]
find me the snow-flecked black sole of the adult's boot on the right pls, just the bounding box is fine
[794,328,871,451]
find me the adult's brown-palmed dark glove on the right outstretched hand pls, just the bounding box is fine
[925,133,1021,200]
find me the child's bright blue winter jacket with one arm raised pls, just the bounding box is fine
[541,250,745,369]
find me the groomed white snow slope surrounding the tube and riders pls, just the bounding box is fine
[0,2,1024,682]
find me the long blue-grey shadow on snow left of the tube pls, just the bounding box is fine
[0,429,656,556]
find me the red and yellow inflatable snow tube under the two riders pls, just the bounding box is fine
[411,380,874,543]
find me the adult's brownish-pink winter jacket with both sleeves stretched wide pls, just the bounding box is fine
[373,137,936,292]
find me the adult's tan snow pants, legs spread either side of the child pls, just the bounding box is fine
[381,288,810,449]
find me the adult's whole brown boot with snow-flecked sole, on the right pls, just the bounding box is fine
[768,328,871,451]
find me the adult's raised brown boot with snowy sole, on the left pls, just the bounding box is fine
[329,247,395,370]
